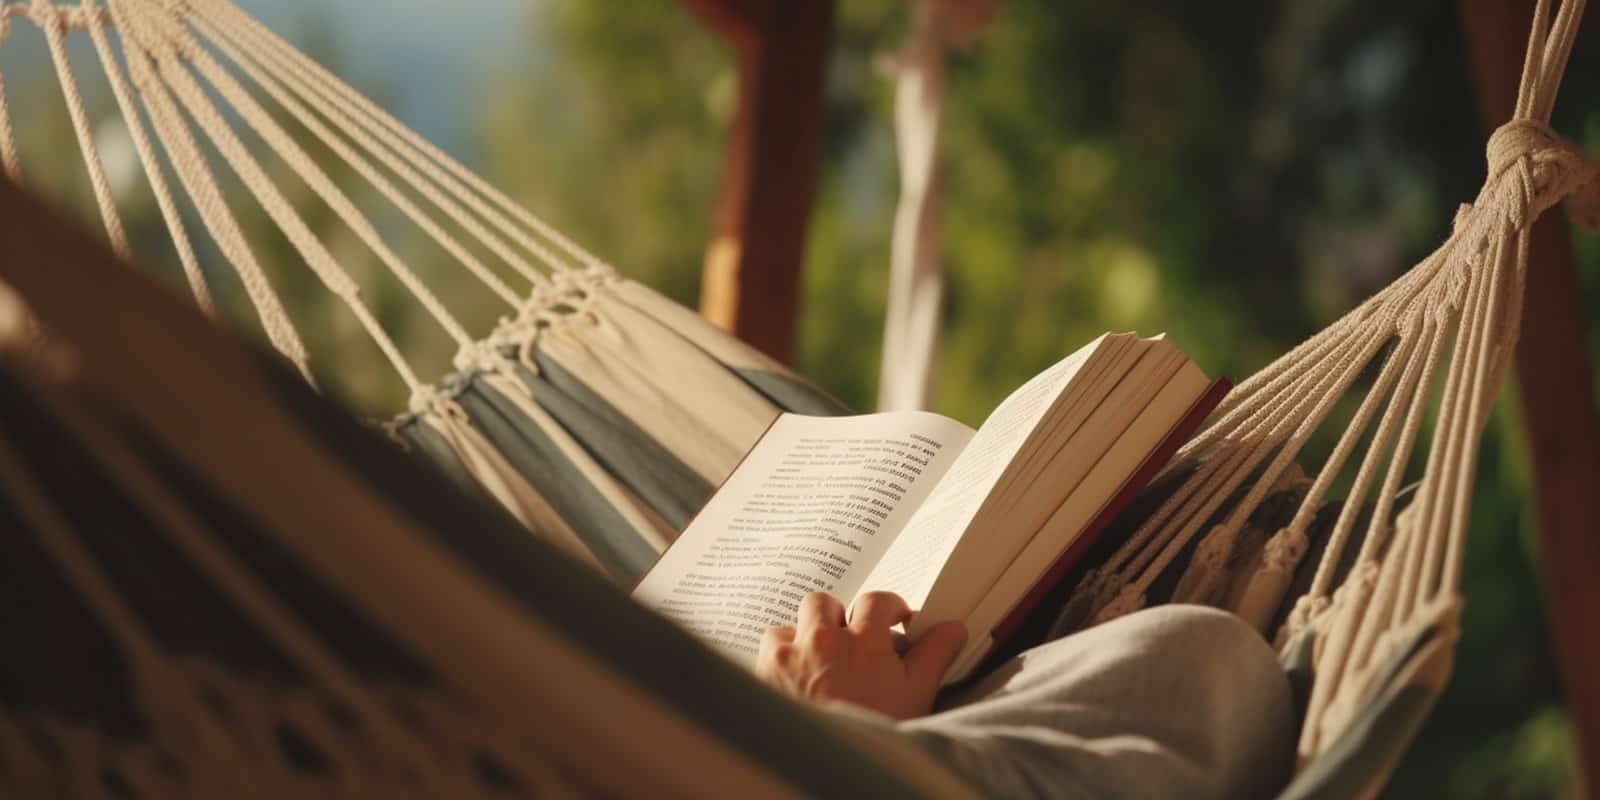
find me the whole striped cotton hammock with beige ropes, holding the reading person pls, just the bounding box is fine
[0,0,1600,797]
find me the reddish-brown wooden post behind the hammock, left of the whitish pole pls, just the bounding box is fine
[683,0,834,363]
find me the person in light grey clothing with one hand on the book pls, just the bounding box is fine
[757,592,1296,798]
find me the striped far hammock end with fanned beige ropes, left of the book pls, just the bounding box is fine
[0,0,843,584]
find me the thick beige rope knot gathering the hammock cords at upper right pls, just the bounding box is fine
[1486,120,1600,227]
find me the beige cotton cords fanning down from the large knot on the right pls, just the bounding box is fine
[1067,2,1600,760]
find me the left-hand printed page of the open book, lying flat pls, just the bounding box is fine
[634,411,973,666]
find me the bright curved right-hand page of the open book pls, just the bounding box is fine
[862,336,1106,608]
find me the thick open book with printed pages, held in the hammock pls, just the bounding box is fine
[634,333,1227,683]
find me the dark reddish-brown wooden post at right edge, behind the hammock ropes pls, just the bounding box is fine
[1461,0,1600,797]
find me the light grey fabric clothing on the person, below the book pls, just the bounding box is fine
[835,605,1296,798]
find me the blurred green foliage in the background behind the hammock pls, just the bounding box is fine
[0,0,1600,798]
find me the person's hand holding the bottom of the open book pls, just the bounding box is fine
[755,592,966,720]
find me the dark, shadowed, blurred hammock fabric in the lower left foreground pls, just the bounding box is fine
[0,188,971,798]
